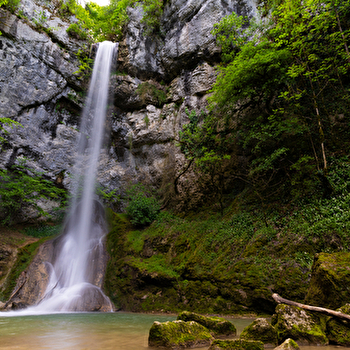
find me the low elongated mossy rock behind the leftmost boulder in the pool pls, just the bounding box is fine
[177,311,237,337]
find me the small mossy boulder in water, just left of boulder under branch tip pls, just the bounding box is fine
[240,318,278,346]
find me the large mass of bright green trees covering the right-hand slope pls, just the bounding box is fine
[196,0,350,201]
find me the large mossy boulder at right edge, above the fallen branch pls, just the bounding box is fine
[306,253,350,310]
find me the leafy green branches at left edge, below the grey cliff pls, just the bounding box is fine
[0,161,66,225]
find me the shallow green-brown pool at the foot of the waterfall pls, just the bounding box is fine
[0,312,349,350]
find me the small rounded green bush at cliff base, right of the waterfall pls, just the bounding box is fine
[126,184,160,226]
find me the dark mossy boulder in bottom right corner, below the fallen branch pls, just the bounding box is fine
[326,304,350,346]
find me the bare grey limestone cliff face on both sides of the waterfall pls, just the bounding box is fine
[0,0,255,221]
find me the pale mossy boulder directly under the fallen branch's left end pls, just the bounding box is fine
[272,304,328,345]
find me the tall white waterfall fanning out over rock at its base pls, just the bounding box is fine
[26,42,116,313]
